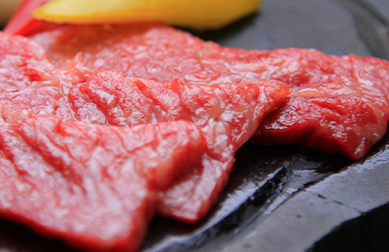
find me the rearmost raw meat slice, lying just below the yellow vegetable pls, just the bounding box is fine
[28,24,389,159]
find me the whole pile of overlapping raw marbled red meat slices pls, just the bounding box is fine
[0,21,389,250]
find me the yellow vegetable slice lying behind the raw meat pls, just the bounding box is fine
[33,0,261,29]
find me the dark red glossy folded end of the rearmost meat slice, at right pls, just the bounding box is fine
[251,96,388,159]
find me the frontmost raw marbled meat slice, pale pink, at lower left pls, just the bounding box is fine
[0,116,206,251]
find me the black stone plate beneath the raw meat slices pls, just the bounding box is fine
[0,0,389,252]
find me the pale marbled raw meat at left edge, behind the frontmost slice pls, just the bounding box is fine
[0,32,95,122]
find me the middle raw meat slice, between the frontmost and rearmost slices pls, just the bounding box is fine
[69,71,289,222]
